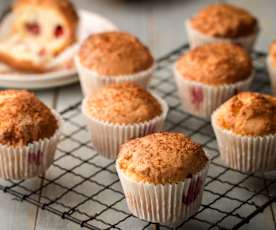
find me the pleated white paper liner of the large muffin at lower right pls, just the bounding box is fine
[212,112,276,172]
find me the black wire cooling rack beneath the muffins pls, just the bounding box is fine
[0,45,276,229]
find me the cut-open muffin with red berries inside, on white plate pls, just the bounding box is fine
[0,0,79,72]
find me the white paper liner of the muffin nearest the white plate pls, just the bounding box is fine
[75,56,155,97]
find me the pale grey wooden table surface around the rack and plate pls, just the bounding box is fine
[0,0,276,230]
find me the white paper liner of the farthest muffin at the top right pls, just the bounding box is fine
[186,20,258,51]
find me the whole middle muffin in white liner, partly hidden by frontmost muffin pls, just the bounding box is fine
[82,82,168,159]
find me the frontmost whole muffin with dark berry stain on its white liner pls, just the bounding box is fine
[116,132,209,224]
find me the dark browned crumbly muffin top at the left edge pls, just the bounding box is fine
[0,90,58,147]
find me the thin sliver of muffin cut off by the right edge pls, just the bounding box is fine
[267,41,276,96]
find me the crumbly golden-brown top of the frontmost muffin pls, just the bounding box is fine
[117,132,208,184]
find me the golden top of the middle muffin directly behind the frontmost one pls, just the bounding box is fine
[86,83,161,124]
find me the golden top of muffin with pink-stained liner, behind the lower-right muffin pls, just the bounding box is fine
[176,42,253,85]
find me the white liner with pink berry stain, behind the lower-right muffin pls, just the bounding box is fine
[174,66,254,119]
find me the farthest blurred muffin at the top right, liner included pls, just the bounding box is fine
[186,3,259,51]
